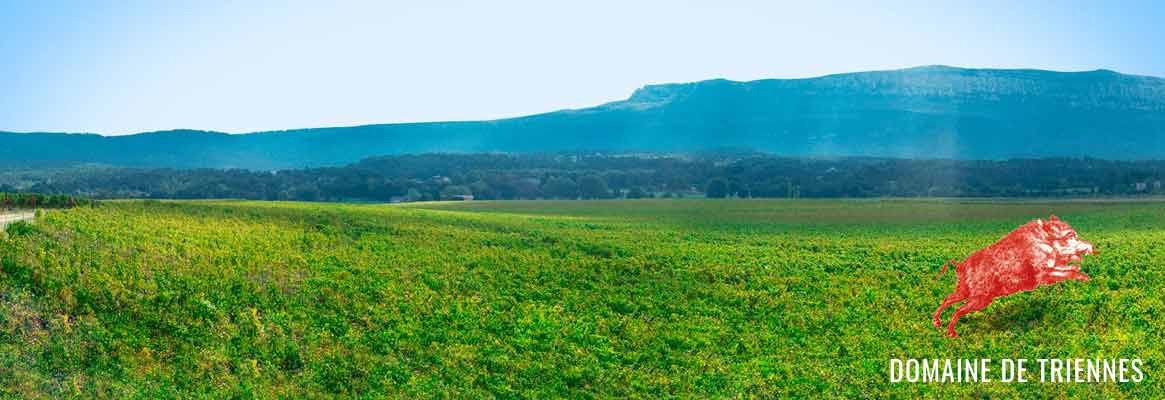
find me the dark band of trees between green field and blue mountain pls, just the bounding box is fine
[0,152,1165,202]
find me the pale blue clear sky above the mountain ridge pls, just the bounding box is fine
[0,0,1165,135]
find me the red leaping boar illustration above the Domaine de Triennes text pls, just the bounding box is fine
[934,216,1095,337]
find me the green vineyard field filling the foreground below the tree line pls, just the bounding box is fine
[0,199,1165,398]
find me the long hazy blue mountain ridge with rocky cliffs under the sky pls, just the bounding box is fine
[0,66,1165,169]
